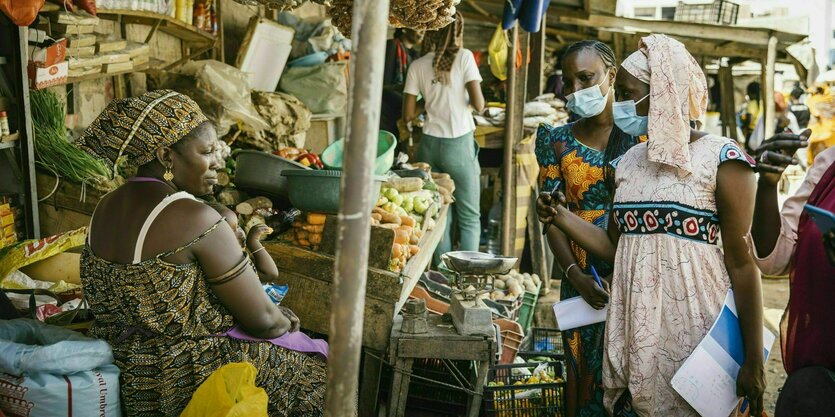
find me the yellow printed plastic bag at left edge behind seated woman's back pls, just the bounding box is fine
[0,228,87,281]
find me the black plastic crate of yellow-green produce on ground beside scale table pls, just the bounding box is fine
[483,362,565,417]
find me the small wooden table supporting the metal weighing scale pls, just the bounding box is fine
[388,314,497,417]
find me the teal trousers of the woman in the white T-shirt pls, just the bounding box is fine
[415,132,481,265]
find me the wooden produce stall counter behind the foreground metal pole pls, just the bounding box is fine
[264,205,449,416]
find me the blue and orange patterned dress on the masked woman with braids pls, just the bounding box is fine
[535,123,642,417]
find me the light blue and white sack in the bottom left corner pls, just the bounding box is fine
[0,319,121,417]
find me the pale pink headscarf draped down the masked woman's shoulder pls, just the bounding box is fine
[621,35,707,172]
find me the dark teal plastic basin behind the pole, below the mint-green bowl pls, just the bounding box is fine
[281,170,385,214]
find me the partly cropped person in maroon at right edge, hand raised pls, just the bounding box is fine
[749,131,835,417]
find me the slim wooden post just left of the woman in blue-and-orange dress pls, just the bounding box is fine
[502,23,519,256]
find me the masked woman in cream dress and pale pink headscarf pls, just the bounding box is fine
[537,35,765,417]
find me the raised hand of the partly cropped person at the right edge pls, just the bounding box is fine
[754,129,812,185]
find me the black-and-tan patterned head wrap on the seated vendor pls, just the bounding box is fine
[77,90,208,172]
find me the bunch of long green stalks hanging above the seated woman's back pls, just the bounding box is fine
[29,90,118,191]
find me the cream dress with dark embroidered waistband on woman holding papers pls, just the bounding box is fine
[603,136,753,417]
